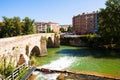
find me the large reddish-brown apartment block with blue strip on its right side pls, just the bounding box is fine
[72,11,98,34]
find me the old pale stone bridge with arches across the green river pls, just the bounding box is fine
[0,33,60,65]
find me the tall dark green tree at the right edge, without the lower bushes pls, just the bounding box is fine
[99,0,120,47]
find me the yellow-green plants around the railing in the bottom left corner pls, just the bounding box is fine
[0,56,28,80]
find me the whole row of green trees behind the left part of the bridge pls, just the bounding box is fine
[0,16,35,38]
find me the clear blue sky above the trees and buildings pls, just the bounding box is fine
[0,0,107,25]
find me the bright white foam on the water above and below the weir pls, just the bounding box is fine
[34,56,76,80]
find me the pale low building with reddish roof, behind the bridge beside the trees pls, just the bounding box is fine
[34,22,59,33]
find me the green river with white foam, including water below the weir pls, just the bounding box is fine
[32,46,120,80]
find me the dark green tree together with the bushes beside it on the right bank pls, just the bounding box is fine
[81,0,120,49]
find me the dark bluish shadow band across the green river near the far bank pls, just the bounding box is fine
[57,48,120,59]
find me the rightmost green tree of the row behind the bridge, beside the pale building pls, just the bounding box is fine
[23,17,35,34]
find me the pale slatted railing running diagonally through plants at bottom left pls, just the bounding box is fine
[0,63,27,80]
